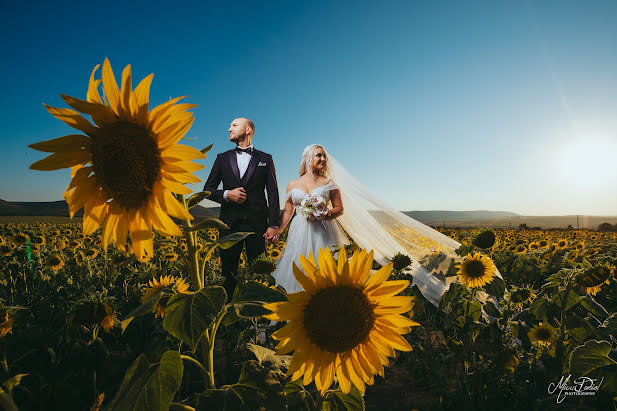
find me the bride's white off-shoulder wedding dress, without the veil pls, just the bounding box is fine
[272,181,349,293]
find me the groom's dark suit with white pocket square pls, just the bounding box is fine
[204,149,280,297]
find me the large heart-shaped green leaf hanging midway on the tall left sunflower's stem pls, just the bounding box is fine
[163,286,227,351]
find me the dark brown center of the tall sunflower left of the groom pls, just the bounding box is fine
[91,121,161,208]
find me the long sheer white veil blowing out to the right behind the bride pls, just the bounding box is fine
[328,153,460,306]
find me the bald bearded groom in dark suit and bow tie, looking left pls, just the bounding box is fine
[204,117,280,298]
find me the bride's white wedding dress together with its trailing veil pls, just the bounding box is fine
[273,154,501,306]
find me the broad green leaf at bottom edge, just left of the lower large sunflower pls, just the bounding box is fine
[195,360,287,411]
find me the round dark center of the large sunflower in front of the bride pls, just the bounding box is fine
[304,285,375,353]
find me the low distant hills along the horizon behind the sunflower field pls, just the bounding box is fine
[0,199,617,229]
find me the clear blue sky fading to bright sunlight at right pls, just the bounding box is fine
[0,0,617,215]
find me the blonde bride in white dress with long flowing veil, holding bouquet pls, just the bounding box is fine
[272,144,460,306]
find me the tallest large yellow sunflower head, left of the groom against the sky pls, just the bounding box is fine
[30,59,206,261]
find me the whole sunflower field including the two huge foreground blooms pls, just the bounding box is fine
[6,59,617,411]
